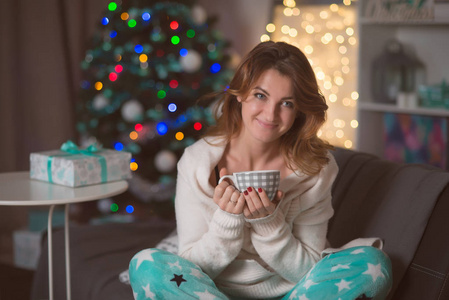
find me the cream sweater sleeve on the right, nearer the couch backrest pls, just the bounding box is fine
[249,155,338,283]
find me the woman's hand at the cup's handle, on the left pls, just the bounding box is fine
[214,168,245,215]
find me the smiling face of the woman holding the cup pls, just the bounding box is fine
[237,69,297,143]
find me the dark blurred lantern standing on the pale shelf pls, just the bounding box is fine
[371,40,424,103]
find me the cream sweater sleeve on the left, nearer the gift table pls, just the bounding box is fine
[175,148,245,279]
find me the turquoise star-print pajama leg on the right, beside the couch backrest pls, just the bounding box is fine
[282,247,392,300]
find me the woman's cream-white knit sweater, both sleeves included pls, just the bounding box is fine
[175,139,338,299]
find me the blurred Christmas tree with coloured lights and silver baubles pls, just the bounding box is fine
[77,0,232,217]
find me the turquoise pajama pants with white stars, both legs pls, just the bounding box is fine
[129,247,392,300]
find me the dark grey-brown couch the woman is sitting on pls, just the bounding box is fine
[31,149,449,300]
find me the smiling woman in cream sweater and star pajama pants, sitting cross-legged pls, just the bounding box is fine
[129,42,391,300]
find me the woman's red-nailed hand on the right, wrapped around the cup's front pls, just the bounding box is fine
[243,187,283,219]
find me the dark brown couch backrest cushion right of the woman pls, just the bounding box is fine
[328,149,449,296]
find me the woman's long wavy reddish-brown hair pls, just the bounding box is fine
[205,41,333,174]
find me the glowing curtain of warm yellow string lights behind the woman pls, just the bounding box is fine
[266,0,358,148]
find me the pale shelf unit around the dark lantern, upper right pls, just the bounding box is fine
[355,0,449,157]
